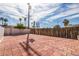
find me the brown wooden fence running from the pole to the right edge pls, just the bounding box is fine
[31,27,79,39]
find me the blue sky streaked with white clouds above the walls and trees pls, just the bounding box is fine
[0,3,79,28]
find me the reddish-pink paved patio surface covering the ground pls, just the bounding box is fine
[0,34,79,56]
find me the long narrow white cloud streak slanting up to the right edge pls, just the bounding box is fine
[47,8,79,21]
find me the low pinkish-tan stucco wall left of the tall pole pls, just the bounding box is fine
[4,28,29,35]
